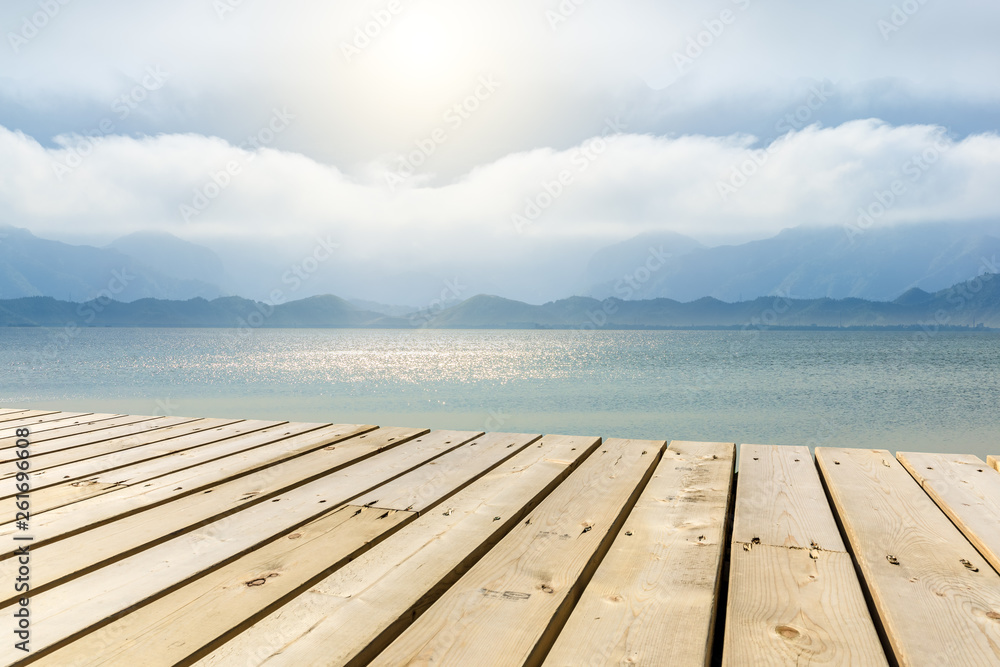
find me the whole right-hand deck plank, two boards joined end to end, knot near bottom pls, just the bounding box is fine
[723,445,887,666]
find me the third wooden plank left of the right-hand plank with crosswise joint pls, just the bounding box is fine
[196,436,600,666]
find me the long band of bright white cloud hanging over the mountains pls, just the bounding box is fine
[0,120,1000,249]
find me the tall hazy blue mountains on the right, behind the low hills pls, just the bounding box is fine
[584,223,1000,302]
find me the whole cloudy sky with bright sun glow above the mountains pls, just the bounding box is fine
[0,0,1000,298]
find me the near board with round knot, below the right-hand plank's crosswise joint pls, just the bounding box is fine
[723,548,888,667]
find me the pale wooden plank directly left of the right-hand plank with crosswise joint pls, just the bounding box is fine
[544,442,736,667]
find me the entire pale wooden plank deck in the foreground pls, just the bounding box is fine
[0,409,1000,667]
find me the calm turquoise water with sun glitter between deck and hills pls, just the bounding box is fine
[0,328,1000,457]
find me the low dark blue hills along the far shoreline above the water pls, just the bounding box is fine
[0,273,1000,332]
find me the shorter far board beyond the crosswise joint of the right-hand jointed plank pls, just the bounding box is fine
[732,445,846,551]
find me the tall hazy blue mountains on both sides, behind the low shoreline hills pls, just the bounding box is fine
[0,222,1000,310]
